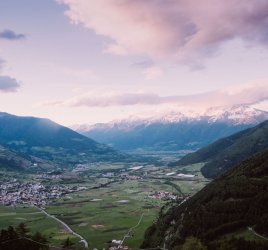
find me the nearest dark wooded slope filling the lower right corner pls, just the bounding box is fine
[142,150,268,249]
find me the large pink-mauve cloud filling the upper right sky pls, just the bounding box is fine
[57,0,268,61]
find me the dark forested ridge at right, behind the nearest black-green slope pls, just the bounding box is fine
[171,121,268,178]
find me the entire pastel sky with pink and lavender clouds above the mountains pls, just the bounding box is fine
[0,0,268,126]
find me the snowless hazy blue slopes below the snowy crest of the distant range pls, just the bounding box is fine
[84,121,251,150]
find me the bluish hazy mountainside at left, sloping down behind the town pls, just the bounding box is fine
[0,113,125,165]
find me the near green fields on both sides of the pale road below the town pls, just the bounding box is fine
[0,180,166,248]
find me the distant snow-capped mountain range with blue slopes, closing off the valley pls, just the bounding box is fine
[75,105,268,150]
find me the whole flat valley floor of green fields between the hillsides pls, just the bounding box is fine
[0,161,208,249]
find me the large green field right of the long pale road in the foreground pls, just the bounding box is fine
[47,180,171,248]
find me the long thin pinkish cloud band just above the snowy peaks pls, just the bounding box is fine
[46,82,268,108]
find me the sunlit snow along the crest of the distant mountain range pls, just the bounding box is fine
[72,105,268,132]
